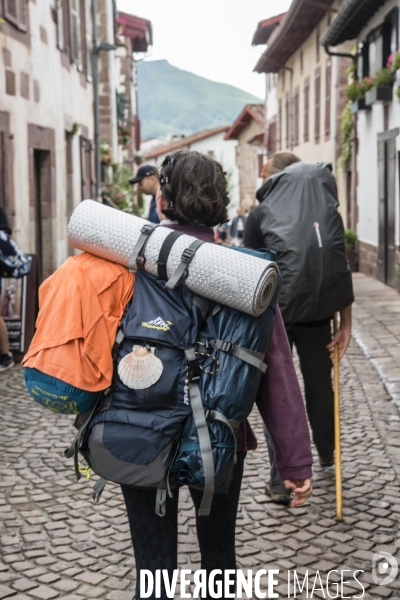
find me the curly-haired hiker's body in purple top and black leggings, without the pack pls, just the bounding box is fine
[111,151,312,598]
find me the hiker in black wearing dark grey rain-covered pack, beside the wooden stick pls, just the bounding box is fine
[244,152,354,504]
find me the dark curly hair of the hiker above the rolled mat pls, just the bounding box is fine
[159,150,229,227]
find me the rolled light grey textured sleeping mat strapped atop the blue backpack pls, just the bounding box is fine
[68,200,278,317]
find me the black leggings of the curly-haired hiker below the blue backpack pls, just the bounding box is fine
[121,452,246,599]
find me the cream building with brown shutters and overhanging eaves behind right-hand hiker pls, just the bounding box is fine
[255,0,352,223]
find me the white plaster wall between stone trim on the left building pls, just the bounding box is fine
[0,0,93,265]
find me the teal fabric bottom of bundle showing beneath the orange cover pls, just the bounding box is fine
[24,367,99,415]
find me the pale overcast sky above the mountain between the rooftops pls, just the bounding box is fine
[117,0,290,98]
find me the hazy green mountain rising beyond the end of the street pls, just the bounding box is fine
[137,60,262,140]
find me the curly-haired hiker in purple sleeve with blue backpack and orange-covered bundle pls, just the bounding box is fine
[25,151,312,598]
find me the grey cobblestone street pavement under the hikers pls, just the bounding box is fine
[0,275,400,600]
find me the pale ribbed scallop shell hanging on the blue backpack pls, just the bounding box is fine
[118,346,164,390]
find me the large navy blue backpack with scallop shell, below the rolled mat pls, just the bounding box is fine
[66,250,279,516]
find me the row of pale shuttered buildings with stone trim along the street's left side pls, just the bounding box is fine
[0,0,151,281]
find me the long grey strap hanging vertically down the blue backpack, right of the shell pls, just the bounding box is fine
[185,348,215,517]
